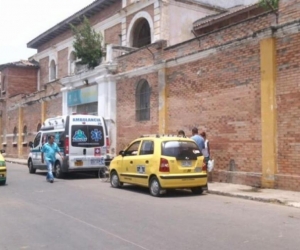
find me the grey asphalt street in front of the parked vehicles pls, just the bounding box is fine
[0,163,300,250]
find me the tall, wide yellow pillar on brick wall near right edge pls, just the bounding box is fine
[260,38,277,188]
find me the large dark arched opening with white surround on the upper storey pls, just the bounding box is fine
[132,18,151,48]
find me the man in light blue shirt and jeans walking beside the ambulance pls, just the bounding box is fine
[41,135,64,183]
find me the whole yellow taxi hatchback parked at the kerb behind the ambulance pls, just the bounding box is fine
[110,135,207,196]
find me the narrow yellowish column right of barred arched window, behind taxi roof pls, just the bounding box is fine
[158,67,168,134]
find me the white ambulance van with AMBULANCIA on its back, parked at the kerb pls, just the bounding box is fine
[28,115,111,178]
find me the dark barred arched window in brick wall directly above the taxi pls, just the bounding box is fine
[135,79,151,121]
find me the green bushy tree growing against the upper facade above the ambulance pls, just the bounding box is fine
[70,16,103,69]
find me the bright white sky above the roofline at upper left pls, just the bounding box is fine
[0,0,94,65]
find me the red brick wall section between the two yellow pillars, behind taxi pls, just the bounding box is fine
[167,41,261,187]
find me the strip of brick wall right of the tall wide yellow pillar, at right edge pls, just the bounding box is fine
[276,33,300,190]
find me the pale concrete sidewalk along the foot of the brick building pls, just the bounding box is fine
[5,158,300,208]
